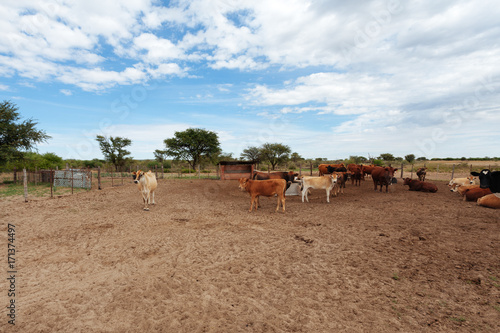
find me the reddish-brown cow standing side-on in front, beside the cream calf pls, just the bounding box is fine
[239,178,287,212]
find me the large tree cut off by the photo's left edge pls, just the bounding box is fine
[0,101,50,165]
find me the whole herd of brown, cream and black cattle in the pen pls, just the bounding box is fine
[132,164,500,212]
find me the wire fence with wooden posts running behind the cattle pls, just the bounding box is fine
[0,162,500,200]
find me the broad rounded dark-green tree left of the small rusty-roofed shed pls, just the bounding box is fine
[164,128,221,169]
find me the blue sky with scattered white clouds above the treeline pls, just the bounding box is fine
[0,0,500,160]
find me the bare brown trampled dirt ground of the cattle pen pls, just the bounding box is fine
[0,176,500,332]
